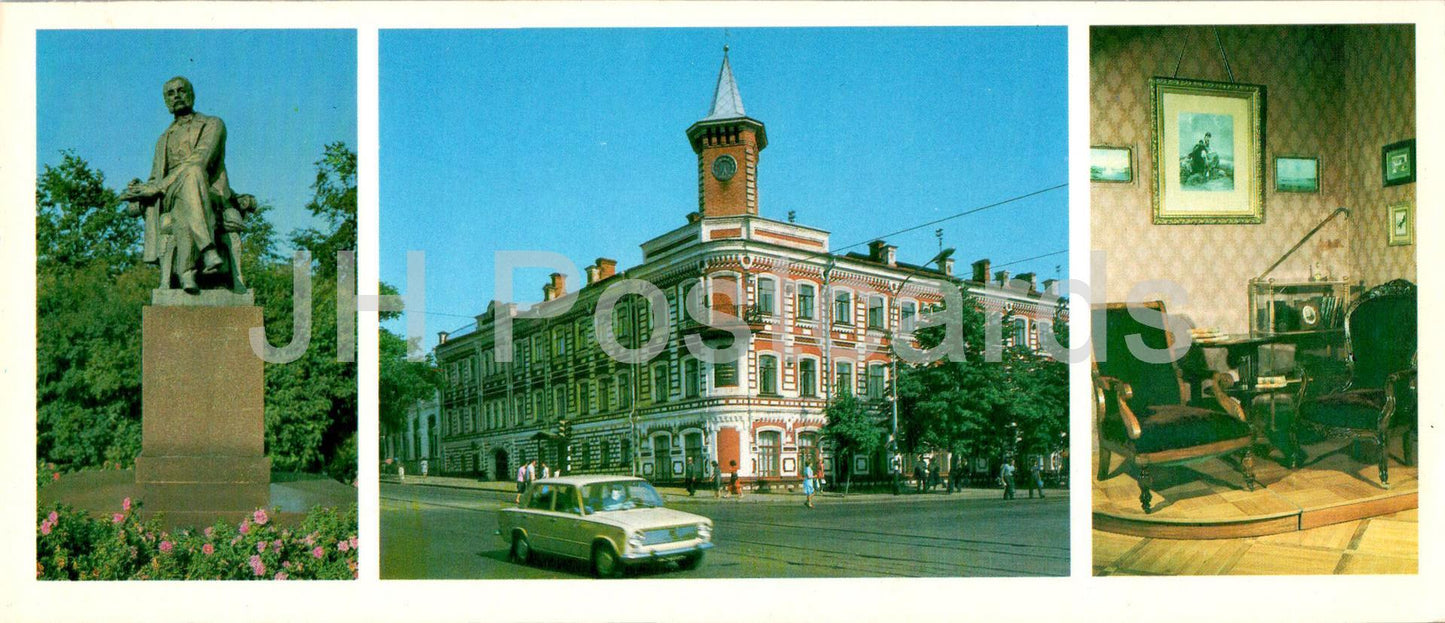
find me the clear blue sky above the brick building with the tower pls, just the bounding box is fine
[380,27,1068,347]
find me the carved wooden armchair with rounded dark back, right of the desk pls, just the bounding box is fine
[1290,279,1419,489]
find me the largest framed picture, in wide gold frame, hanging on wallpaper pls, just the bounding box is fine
[1149,77,1264,224]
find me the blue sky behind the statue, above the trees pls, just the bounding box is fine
[36,30,357,245]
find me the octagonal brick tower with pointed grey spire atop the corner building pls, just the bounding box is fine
[688,46,767,218]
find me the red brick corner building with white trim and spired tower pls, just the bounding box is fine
[436,53,1055,481]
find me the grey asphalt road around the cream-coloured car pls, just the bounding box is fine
[381,483,1069,580]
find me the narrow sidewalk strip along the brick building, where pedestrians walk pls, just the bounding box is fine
[381,474,1069,504]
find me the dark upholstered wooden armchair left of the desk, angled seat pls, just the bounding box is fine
[1094,301,1256,513]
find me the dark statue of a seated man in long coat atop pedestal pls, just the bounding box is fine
[120,77,256,293]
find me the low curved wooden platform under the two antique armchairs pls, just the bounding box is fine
[1094,437,1419,539]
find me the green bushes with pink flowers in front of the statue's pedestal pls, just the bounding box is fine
[35,497,357,580]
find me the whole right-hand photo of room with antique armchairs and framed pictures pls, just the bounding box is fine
[1090,25,1419,575]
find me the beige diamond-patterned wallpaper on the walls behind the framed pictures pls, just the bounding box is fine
[1090,26,1415,332]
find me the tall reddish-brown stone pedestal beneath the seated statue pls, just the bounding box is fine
[136,296,270,519]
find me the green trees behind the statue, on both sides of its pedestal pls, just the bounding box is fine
[36,143,357,480]
